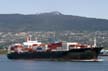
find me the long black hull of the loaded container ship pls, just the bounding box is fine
[7,47,102,60]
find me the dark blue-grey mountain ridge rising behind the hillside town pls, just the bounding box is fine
[0,11,108,32]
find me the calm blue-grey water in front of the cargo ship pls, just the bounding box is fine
[0,55,108,71]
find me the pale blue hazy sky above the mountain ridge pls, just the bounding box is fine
[0,0,108,19]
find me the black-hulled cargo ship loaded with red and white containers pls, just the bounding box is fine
[7,35,103,61]
